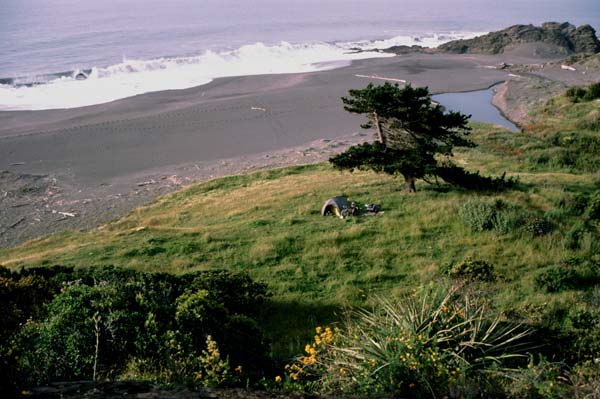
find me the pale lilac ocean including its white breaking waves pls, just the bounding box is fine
[0,0,600,110]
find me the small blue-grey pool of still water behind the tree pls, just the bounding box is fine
[431,87,520,132]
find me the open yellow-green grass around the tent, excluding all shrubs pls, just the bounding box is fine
[0,95,598,355]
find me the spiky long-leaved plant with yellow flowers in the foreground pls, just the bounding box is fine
[287,288,529,398]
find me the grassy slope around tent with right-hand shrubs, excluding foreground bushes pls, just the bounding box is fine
[0,84,600,396]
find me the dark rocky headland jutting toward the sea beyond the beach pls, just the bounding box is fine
[437,22,600,55]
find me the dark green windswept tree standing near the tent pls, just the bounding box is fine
[329,83,475,192]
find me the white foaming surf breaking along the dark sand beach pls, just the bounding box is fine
[0,34,486,110]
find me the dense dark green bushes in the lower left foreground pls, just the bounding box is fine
[2,268,268,385]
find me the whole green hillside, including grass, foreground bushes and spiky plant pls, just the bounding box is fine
[0,86,600,398]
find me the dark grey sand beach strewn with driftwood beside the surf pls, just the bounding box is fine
[0,54,591,248]
